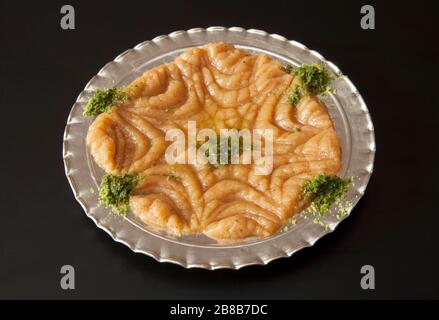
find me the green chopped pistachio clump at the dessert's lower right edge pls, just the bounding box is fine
[302,174,353,215]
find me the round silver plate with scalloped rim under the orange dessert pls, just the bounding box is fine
[63,27,375,269]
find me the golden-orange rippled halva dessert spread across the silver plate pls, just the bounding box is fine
[84,43,341,241]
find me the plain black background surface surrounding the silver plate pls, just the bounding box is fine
[0,0,439,299]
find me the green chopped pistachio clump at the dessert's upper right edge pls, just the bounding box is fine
[288,63,335,105]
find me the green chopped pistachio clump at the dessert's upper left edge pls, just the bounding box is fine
[83,88,128,116]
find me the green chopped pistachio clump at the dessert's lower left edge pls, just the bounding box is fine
[99,174,142,216]
